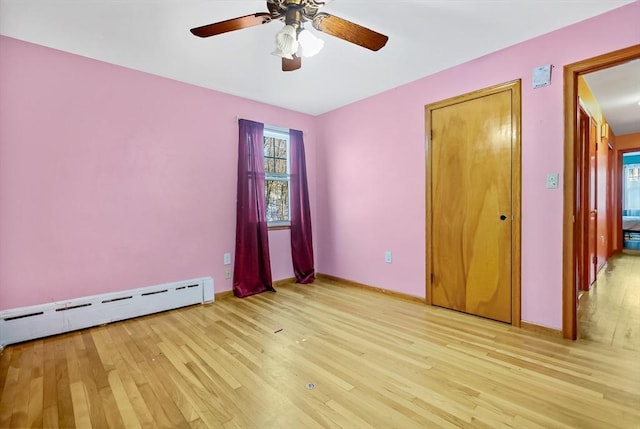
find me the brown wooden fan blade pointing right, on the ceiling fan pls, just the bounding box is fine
[313,12,389,51]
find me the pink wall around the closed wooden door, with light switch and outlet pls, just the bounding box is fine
[317,2,640,329]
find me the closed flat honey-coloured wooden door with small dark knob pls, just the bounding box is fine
[427,82,519,322]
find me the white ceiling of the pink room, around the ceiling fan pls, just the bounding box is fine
[0,0,633,117]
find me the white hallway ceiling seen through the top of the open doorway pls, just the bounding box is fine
[584,59,640,136]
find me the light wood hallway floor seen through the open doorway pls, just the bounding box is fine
[578,250,640,351]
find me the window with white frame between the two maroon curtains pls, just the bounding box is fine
[263,126,291,227]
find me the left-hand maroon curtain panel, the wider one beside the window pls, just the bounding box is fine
[233,119,274,298]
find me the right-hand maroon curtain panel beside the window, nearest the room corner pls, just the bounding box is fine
[289,130,315,284]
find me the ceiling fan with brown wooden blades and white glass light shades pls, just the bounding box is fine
[191,0,389,71]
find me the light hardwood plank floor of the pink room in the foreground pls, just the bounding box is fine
[0,280,640,429]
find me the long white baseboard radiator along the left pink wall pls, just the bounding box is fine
[0,277,214,349]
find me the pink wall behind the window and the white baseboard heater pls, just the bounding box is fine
[0,37,316,309]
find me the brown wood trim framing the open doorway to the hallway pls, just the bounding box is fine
[562,45,640,340]
